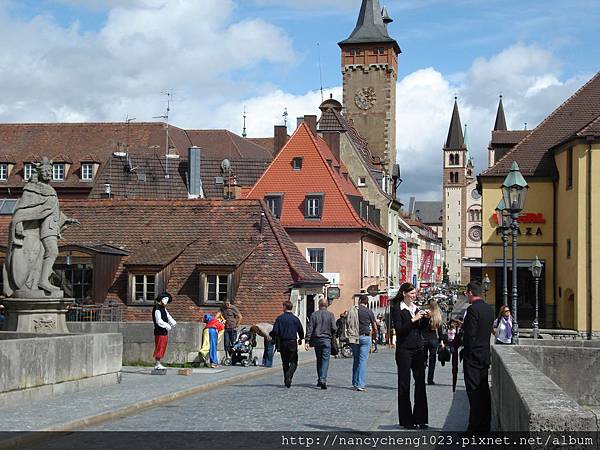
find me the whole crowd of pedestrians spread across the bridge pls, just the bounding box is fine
[150,281,496,432]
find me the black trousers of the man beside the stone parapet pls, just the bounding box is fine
[463,359,492,432]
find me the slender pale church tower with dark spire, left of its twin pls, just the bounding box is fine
[443,97,473,282]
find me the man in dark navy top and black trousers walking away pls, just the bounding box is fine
[271,300,304,388]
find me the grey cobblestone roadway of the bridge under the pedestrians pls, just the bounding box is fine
[87,349,468,431]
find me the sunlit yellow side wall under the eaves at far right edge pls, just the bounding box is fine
[555,144,600,333]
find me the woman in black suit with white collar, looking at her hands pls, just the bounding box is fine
[391,283,429,429]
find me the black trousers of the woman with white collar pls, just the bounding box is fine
[396,347,429,426]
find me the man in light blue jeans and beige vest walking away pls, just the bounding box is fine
[348,295,377,391]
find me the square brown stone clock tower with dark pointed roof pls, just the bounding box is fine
[338,0,401,173]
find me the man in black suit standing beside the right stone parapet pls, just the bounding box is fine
[462,281,494,432]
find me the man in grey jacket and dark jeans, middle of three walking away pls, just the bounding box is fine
[305,294,337,389]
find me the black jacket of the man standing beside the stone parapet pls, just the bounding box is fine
[462,299,494,368]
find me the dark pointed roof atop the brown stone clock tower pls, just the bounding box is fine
[338,0,401,53]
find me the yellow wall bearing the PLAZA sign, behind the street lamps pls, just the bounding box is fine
[481,178,554,324]
